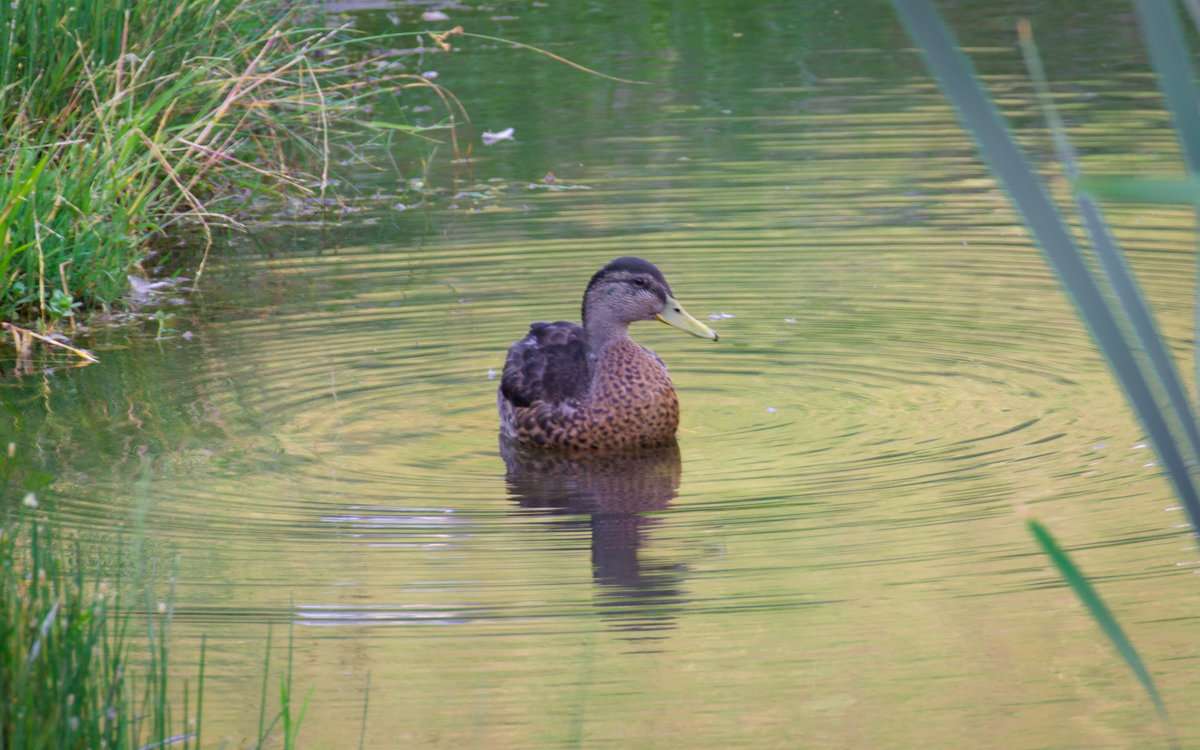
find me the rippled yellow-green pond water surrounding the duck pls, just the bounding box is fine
[0,2,1200,748]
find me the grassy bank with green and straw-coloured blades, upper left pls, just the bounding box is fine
[0,0,451,329]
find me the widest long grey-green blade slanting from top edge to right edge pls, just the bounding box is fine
[893,0,1200,534]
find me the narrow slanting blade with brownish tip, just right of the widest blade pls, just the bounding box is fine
[1020,20,1200,482]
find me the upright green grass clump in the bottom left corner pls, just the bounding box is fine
[0,508,307,750]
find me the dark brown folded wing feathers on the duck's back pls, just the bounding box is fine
[500,320,592,408]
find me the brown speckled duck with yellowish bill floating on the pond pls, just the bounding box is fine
[496,256,718,452]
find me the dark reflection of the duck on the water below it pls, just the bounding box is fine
[500,437,683,628]
